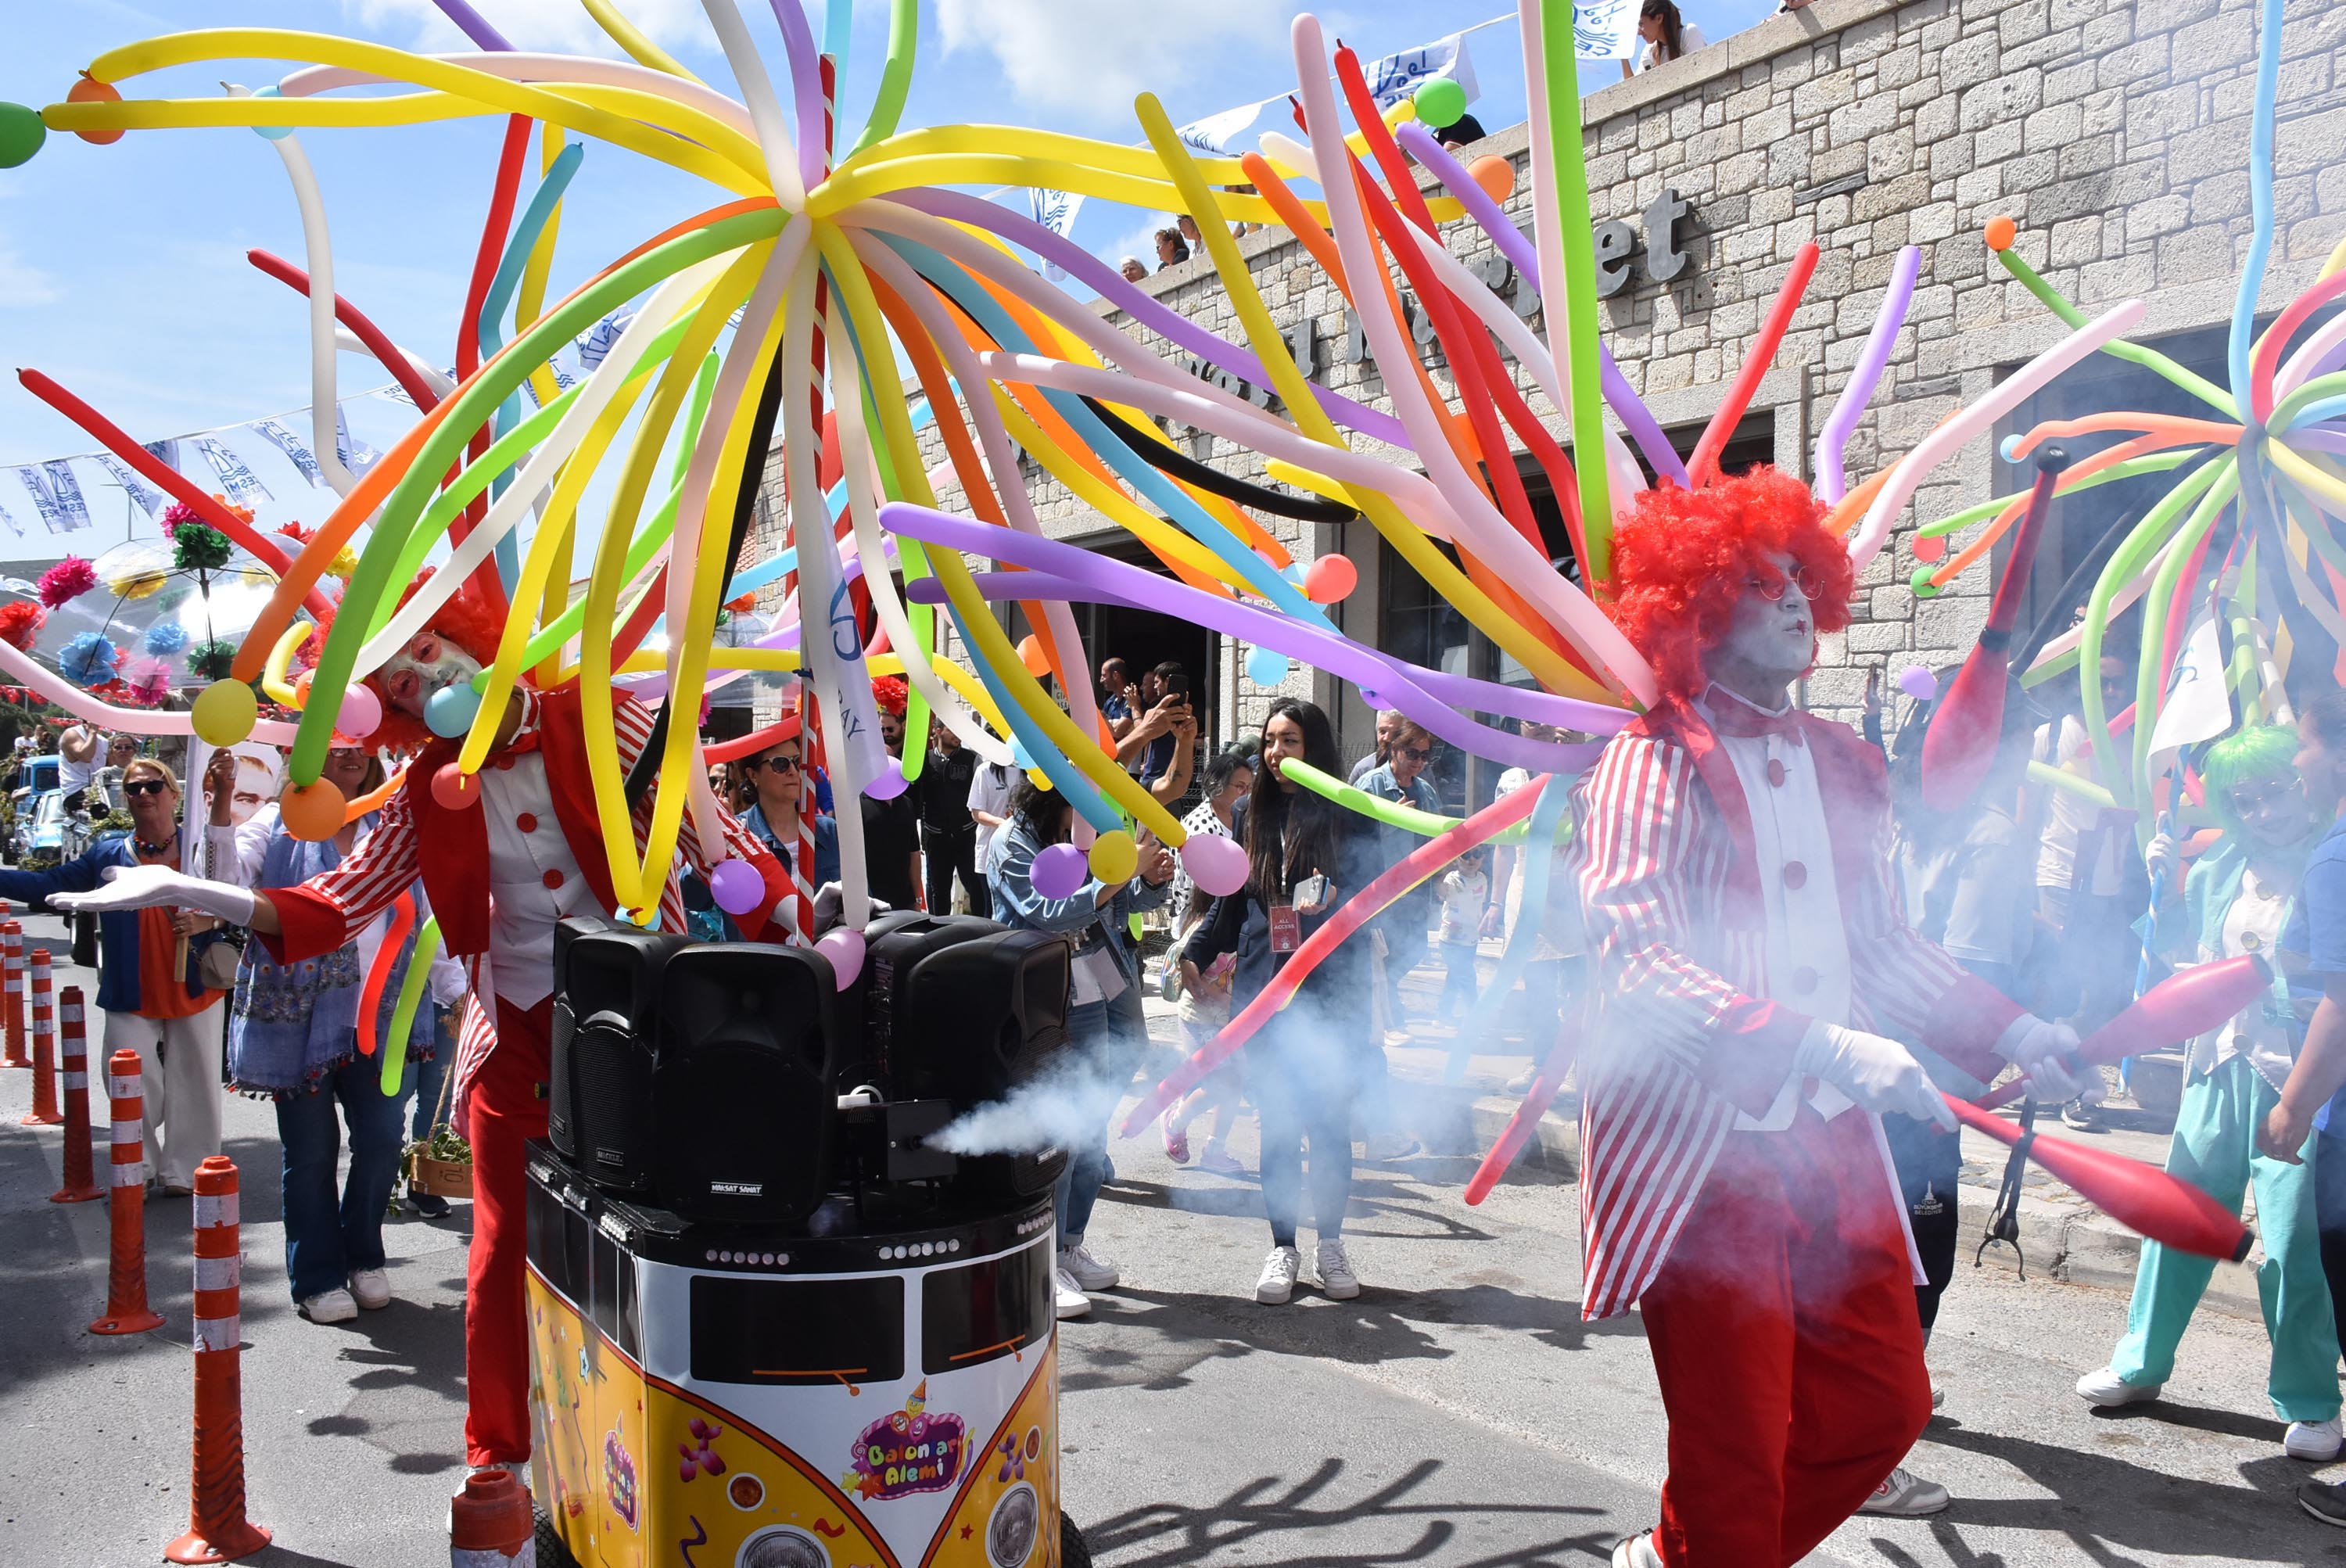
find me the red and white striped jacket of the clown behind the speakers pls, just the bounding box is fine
[260,685,793,1127]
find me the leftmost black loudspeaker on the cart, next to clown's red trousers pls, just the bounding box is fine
[547,920,692,1195]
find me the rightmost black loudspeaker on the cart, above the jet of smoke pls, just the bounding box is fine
[889,932,1070,1195]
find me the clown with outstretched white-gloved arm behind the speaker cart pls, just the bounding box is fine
[55,579,793,1467]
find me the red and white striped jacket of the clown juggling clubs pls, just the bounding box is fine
[1567,699,2020,1319]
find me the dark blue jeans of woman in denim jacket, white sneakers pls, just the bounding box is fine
[277,1057,415,1301]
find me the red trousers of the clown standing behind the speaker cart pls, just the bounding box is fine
[465,998,554,1465]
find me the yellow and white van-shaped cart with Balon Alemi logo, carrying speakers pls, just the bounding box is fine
[528,918,1091,1568]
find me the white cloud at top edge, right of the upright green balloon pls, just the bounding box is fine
[936,0,1293,124]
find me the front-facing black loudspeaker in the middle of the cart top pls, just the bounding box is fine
[647,942,842,1225]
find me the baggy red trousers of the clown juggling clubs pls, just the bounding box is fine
[1642,1106,1931,1568]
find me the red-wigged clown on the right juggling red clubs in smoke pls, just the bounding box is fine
[1572,467,2076,1568]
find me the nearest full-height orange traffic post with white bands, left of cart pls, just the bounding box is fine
[162,1155,270,1563]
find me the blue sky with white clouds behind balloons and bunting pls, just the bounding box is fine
[0,0,1774,554]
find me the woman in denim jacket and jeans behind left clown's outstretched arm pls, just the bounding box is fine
[206,737,465,1324]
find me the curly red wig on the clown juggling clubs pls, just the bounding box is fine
[1609,465,1858,697]
